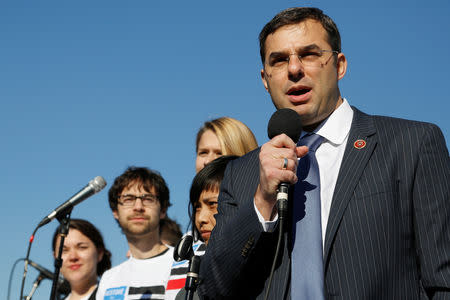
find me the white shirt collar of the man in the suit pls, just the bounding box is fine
[302,98,353,145]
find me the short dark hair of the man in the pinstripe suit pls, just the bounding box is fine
[259,7,341,65]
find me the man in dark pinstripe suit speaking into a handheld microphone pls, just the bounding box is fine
[199,8,450,299]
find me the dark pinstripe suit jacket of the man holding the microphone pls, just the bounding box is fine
[199,108,450,299]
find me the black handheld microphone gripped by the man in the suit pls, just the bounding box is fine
[267,108,302,218]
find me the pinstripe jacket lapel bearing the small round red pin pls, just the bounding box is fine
[324,107,377,270]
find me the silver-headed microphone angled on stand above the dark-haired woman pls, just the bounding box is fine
[38,176,106,227]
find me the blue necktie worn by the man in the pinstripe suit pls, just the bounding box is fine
[291,134,325,300]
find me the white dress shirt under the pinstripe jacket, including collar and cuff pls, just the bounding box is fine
[255,98,353,244]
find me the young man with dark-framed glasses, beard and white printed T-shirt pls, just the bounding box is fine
[96,167,173,300]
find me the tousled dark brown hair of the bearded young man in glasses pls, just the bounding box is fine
[108,167,170,212]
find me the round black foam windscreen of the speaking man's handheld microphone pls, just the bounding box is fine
[267,108,302,143]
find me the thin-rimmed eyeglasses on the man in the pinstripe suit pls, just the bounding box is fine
[267,50,339,71]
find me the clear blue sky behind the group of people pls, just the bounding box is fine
[0,0,450,300]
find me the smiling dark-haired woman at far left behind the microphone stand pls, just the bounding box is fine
[52,219,111,300]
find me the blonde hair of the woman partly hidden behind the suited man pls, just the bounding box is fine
[195,117,258,156]
